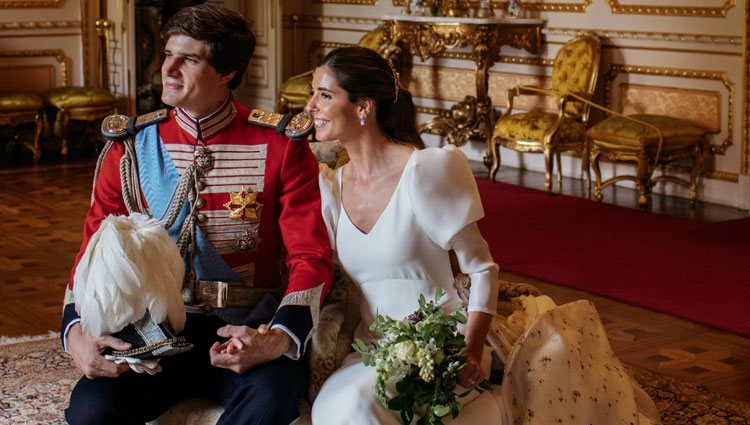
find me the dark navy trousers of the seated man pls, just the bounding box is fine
[65,314,308,425]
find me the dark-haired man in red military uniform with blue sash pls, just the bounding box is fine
[62,5,333,424]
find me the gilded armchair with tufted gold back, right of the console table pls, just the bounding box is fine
[489,33,601,192]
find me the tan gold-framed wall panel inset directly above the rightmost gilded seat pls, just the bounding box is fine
[619,84,721,133]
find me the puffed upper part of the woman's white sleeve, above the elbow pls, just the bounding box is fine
[408,145,484,250]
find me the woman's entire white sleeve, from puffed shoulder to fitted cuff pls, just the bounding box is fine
[409,145,499,315]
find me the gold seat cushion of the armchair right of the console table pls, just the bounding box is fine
[493,111,586,144]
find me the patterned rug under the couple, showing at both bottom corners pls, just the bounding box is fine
[0,336,750,425]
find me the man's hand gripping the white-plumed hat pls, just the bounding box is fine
[68,322,131,379]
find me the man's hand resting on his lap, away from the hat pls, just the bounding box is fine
[209,325,292,373]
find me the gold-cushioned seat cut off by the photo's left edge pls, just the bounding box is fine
[0,93,44,161]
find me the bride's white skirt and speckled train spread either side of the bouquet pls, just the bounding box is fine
[312,297,660,425]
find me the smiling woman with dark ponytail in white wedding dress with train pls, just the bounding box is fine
[307,47,658,425]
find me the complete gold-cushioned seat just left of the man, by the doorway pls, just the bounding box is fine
[42,86,115,157]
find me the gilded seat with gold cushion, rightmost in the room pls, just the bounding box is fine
[588,114,706,209]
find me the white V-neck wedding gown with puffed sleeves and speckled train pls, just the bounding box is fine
[312,145,658,425]
